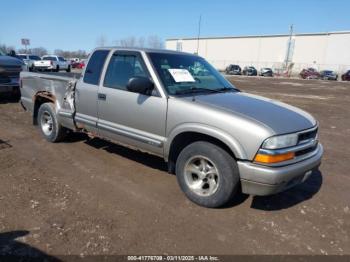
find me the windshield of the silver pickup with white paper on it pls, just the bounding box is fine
[148,53,238,95]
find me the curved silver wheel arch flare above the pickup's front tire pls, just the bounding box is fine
[164,123,247,161]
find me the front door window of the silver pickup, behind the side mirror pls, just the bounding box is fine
[103,54,148,90]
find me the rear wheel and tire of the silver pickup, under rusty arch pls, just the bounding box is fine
[37,103,68,143]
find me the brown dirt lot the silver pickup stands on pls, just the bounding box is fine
[0,77,350,256]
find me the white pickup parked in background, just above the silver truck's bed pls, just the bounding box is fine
[33,55,71,72]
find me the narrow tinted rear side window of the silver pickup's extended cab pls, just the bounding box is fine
[84,50,109,85]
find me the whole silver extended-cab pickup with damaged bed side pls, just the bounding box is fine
[20,48,323,207]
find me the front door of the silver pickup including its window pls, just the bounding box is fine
[98,51,167,156]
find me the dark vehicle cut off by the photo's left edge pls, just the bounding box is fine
[0,50,26,96]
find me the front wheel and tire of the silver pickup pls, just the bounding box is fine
[176,141,240,208]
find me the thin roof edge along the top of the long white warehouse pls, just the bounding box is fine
[166,30,350,41]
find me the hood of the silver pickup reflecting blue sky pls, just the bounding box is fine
[186,92,316,134]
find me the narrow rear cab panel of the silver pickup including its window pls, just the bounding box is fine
[75,50,109,133]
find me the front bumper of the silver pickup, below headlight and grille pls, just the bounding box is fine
[237,144,323,196]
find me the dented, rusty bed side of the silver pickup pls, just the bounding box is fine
[20,72,78,130]
